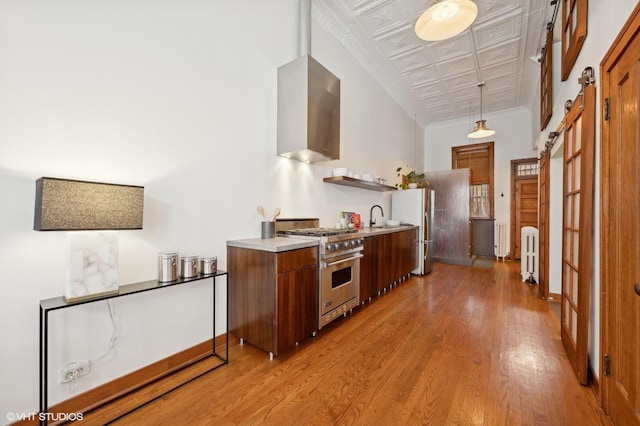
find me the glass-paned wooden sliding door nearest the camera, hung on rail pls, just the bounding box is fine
[561,81,595,385]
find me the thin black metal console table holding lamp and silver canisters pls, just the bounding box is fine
[39,271,229,424]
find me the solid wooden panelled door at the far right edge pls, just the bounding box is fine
[600,2,640,425]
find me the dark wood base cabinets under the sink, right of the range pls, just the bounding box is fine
[360,228,418,303]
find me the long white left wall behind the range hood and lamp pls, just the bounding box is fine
[0,0,423,418]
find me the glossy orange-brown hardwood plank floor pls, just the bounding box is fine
[82,262,610,426]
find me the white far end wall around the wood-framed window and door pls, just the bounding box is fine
[424,108,537,236]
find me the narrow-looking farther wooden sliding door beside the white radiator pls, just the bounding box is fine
[538,150,551,299]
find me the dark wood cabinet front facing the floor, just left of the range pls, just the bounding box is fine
[275,265,318,355]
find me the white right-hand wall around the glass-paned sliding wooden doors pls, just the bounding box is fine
[532,0,637,382]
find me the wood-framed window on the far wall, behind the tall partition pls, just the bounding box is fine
[451,142,494,219]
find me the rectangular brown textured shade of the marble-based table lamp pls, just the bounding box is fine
[33,177,144,231]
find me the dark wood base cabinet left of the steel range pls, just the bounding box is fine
[227,246,318,355]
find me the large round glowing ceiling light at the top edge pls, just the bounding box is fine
[415,0,478,41]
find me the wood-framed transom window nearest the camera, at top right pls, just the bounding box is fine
[561,0,587,81]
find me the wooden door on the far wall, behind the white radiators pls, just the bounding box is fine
[511,158,538,259]
